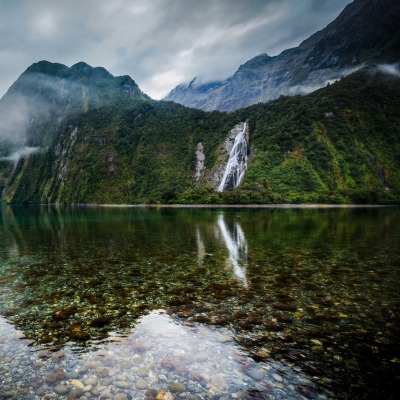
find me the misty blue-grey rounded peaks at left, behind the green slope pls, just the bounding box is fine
[0,61,149,148]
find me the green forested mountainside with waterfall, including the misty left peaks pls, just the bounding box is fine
[0,64,400,204]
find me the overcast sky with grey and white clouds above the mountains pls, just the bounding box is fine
[0,0,351,99]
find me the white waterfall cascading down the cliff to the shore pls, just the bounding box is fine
[217,122,248,192]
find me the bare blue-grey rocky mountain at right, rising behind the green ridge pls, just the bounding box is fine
[166,0,400,111]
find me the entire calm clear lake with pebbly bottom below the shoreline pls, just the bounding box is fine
[0,206,400,400]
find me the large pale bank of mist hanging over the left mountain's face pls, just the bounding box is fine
[0,72,82,161]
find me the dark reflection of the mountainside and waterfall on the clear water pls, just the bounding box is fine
[0,207,400,399]
